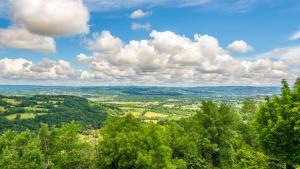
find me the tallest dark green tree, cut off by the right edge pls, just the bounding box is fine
[256,78,300,168]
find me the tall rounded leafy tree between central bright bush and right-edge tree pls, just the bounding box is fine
[190,101,239,168]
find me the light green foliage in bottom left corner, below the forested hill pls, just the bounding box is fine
[0,123,95,169]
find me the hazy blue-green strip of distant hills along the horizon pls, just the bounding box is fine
[0,85,280,100]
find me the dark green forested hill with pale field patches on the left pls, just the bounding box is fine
[0,95,113,131]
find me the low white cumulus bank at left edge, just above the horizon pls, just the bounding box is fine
[0,58,90,81]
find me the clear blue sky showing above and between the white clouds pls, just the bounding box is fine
[0,0,300,85]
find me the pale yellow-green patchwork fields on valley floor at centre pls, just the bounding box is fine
[92,98,201,123]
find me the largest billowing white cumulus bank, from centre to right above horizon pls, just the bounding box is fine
[77,31,297,85]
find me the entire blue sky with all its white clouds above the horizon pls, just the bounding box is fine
[0,0,300,86]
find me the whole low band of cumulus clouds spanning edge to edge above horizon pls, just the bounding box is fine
[0,28,300,86]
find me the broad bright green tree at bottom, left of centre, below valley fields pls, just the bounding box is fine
[97,115,186,169]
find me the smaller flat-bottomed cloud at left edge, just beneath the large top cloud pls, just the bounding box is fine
[0,28,56,53]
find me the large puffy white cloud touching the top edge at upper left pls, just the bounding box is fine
[9,0,89,36]
